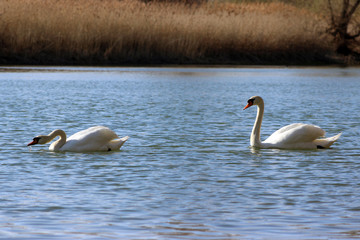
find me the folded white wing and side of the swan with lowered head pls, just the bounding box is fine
[61,126,119,152]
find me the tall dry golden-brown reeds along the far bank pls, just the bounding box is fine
[0,0,333,65]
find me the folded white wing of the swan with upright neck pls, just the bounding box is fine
[264,123,325,145]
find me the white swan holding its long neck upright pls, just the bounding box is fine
[243,96,341,149]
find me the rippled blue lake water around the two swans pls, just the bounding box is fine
[0,67,360,240]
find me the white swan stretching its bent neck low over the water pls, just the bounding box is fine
[28,126,129,152]
